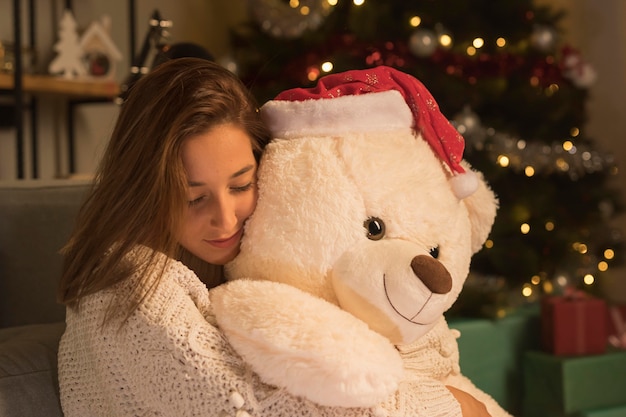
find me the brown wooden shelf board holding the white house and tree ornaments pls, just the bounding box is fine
[0,73,120,99]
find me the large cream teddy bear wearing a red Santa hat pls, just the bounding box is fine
[211,67,508,417]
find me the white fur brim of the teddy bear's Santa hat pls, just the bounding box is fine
[261,90,414,139]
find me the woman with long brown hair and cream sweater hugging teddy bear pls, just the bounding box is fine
[58,58,488,417]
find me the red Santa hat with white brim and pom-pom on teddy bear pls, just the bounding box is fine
[261,66,478,199]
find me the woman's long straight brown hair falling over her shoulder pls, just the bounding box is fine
[57,58,269,322]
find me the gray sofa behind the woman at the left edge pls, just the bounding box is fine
[0,179,89,417]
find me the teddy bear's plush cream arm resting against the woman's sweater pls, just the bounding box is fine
[210,279,403,407]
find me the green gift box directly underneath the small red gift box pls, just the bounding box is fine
[523,351,626,417]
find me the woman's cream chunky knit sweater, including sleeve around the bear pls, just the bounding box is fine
[59,250,478,417]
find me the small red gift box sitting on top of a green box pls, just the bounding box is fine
[541,293,608,356]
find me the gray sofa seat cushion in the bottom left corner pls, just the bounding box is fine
[0,322,65,417]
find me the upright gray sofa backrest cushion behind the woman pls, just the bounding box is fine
[0,180,88,328]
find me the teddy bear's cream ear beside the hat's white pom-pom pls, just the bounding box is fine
[462,161,498,253]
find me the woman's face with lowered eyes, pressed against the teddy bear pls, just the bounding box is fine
[180,124,257,265]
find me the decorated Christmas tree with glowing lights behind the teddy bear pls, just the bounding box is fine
[227,0,624,315]
